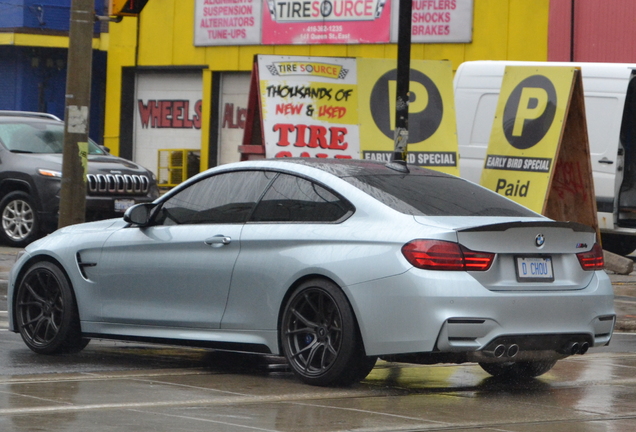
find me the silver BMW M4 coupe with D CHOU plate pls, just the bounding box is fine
[8,159,615,385]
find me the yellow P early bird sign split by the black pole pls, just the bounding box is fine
[358,59,459,175]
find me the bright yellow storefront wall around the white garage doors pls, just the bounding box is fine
[104,0,550,168]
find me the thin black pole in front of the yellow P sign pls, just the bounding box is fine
[388,0,413,172]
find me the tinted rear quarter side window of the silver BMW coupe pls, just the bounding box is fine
[251,174,351,222]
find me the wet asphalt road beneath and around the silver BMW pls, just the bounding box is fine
[0,246,636,432]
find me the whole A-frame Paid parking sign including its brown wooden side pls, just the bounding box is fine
[481,66,597,228]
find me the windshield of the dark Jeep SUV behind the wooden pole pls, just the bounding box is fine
[0,121,106,155]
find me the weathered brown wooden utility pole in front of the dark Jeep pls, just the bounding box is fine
[58,0,95,228]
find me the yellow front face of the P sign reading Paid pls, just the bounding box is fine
[481,66,577,213]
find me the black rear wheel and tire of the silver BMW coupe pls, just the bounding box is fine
[279,279,376,386]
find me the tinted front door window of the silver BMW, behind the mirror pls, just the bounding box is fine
[156,171,274,225]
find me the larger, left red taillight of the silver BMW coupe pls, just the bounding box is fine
[402,240,495,271]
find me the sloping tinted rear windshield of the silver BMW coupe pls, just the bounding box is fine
[341,171,537,217]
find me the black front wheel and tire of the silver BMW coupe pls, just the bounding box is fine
[14,261,89,354]
